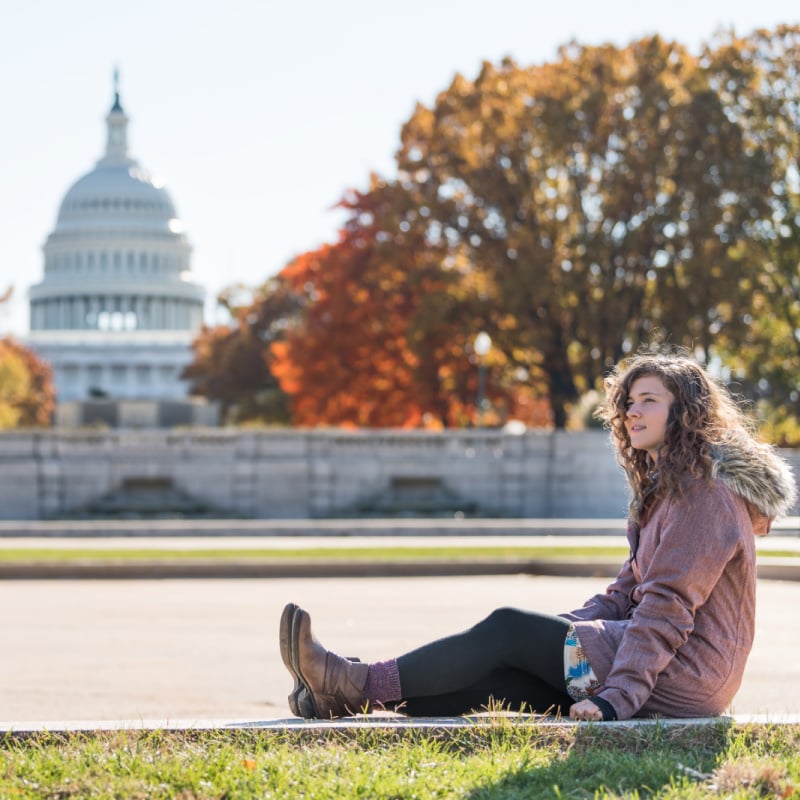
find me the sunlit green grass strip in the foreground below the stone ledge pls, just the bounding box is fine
[0,718,800,800]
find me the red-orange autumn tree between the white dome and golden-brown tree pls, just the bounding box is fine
[271,177,548,428]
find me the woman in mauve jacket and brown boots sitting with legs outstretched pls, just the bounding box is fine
[280,346,796,720]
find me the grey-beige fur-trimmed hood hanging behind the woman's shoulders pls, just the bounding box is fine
[711,432,797,533]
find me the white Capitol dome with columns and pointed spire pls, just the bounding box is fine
[29,83,205,333]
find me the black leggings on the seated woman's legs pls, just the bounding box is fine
[397,608,574,717]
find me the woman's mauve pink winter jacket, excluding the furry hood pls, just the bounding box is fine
[562,480,757,719]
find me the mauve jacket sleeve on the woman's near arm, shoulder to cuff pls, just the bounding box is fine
[598,481,742,719]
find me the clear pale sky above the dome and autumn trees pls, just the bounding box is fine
[0,0,800,336]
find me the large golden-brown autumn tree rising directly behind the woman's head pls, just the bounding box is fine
[398,37,770,426]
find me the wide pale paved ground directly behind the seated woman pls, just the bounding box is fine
[0,575,800,730]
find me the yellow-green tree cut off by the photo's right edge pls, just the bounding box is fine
[703,26,800,445]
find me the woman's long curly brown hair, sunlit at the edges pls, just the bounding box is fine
[595,351,752,522]
